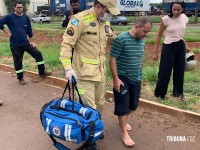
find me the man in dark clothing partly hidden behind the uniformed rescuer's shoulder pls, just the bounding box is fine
[62,0,82,27]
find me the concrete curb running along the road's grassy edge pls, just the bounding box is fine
[0,63,200,121]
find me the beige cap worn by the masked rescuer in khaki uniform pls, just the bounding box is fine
[98,0,120,15]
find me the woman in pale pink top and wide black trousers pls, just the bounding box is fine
[153,1,189,100]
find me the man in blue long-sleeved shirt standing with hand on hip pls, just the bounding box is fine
[0,1,51,85]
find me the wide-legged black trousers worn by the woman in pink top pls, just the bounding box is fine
[155,40,185,97]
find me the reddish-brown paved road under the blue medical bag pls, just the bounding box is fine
[0,71,200,150]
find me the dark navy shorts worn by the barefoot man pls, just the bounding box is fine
[113,76,141,116]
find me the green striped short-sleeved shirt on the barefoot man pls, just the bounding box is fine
[110,31,145,81]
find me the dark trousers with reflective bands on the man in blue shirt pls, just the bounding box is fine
[11,45,45,79]
